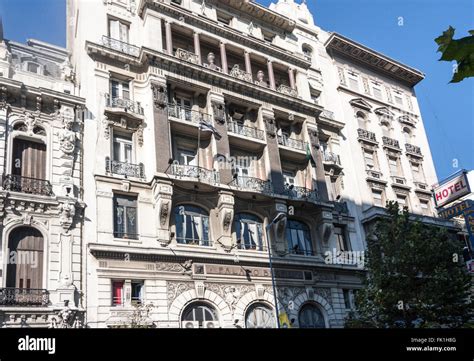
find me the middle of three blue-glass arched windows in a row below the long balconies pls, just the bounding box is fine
[234,213,263,251]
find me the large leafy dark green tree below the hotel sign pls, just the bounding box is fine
[346,202,473,328]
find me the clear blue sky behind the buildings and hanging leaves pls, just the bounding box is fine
[0,0,474,179]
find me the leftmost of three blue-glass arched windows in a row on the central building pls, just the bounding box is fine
[174,204,210,246]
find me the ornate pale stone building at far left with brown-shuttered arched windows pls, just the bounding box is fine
[0,20,84,327]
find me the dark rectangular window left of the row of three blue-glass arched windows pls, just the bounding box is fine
[114,194,138,239]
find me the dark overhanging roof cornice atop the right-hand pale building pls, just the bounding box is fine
[325,33,425,87]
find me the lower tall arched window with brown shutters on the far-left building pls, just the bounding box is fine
[6,227,44,290]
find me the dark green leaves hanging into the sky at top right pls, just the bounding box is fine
[435,26,474,83]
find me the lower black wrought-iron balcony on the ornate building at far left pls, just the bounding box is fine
[0,287,49,307]
